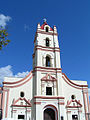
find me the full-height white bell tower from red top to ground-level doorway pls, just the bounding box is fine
[32,21,64,120]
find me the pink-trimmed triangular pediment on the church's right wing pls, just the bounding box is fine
[66,100,82,108]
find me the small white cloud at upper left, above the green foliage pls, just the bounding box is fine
[0,14,11,28]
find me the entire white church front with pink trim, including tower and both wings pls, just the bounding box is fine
[0,22,90,120]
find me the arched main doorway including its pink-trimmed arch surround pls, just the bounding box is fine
[43,105,58,120]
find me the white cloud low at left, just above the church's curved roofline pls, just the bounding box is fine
[0,65,29,82]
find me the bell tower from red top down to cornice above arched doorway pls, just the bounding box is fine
[33,21,62,96]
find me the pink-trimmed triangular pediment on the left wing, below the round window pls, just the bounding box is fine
[12,98,31,107]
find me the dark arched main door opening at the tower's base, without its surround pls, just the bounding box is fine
[44,108,55,120]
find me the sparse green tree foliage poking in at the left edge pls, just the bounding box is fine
[0,29,10,50]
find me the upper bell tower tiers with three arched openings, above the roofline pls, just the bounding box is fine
[33,22,61,68]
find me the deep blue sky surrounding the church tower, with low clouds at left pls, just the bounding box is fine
[0,0,90,92]
